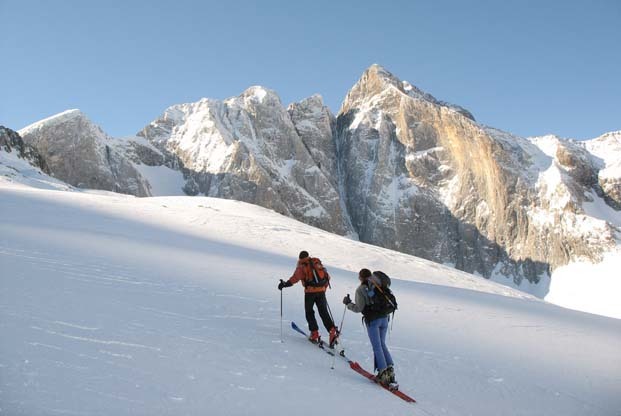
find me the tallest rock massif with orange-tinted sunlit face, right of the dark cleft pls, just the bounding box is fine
[337,66,614,283]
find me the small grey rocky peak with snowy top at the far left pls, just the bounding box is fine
[20,110,150,196]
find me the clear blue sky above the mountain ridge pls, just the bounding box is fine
[0,0,621,139]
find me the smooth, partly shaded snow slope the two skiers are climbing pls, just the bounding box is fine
[0,182,621,416]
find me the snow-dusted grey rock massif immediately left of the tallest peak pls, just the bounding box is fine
[138,87,351,234]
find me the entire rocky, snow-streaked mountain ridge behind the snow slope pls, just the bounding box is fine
[7,65,621,300]
